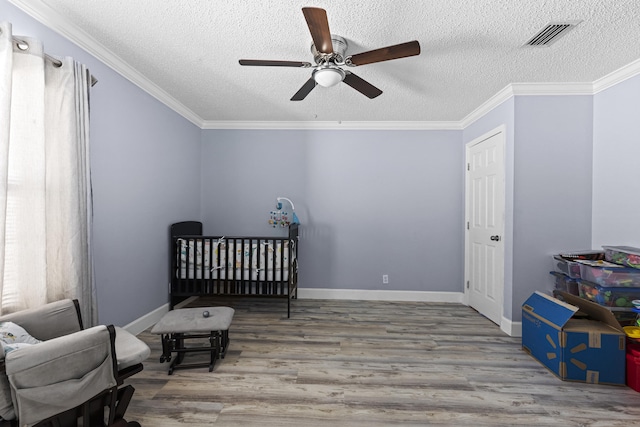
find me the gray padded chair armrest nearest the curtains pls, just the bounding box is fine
[0,299,82,341]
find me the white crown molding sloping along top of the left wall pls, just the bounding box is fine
[9,0,203,127]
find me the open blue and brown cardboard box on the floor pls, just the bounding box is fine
[522,292,626,385]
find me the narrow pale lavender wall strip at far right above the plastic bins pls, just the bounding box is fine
[592,75,640,248]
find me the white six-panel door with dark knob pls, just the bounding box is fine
[465,130,505,325]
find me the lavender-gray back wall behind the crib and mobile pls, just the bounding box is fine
[202,130,464,292]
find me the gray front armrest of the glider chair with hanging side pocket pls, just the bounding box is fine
[5,326,117,425]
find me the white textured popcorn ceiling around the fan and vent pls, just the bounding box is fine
[7,0,640,127]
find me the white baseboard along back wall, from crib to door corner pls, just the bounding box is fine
[298,288,464,304]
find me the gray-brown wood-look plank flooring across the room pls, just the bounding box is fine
[126,299,640,427]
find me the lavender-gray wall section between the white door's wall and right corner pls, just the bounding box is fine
[511,96,593,321]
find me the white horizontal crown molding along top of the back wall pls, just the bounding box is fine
[201,120,462,130]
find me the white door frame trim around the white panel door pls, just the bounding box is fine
[463,125,507,320]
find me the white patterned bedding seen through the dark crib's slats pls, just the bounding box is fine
[176,238,295,281]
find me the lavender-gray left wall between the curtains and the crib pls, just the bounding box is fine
[0,0,200,325]
